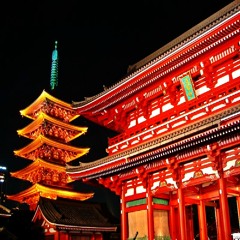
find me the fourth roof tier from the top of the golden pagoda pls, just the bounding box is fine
[10,159,73,186]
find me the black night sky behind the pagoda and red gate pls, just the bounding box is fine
[0,0,232,210]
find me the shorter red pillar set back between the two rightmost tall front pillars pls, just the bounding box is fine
[198,199,208,240]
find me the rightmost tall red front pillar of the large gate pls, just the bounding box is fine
[218,174,232,240]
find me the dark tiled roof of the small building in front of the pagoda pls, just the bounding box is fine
[33,198,117,232]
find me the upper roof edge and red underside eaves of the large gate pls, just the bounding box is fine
[72,0,239,115]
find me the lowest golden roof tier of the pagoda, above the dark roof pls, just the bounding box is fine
[6,183,94,210]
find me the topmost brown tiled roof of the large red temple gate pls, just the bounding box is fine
[72,0,240,109]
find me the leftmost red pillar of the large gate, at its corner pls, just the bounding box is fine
[121,183,128,240]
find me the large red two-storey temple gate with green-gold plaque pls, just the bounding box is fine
[67,1,240,240]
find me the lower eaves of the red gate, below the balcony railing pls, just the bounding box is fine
[67,109,240,179]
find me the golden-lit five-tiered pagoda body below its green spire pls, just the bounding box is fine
[8,90,93,209]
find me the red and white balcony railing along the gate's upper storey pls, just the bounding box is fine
[108,60,240,155]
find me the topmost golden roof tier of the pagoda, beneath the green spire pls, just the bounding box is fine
[20,90,79,122]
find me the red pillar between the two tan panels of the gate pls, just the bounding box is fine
[146,177,154,240]
